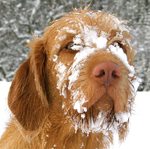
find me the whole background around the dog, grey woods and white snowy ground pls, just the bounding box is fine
[0,0,150,149]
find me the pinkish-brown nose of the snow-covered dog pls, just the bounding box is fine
[92,62,120,87]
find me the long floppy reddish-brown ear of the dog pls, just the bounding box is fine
[8,39,48,131]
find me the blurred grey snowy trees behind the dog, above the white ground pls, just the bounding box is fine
[0,0,150,91]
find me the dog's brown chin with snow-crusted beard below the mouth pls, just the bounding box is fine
[68,94,129,135]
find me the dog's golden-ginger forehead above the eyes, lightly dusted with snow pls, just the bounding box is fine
[48,10,131,56]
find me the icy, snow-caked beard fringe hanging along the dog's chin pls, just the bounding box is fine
[70,108,130,136]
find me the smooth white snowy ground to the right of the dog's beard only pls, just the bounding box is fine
[111,92,150,149]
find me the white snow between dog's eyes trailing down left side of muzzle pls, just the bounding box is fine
[68,26,107,90]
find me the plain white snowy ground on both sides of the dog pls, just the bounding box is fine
[0,81,150,149]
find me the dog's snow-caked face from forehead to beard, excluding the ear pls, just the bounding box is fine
[47,11,137,138]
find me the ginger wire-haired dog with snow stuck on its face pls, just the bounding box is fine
[0,9,137,149]
